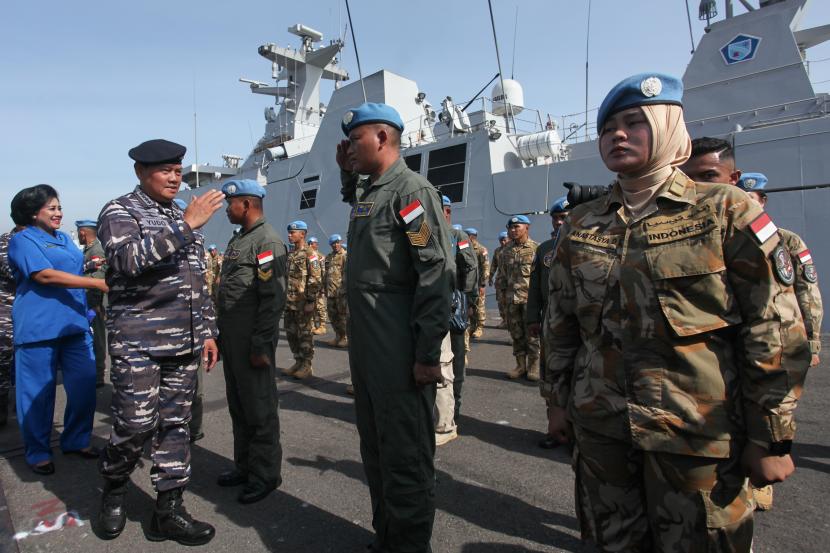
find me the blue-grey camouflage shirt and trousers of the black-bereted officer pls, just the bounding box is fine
[98,186,217,492]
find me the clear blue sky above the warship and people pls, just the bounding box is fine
[0,0,830,231]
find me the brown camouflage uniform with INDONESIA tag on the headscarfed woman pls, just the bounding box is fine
[542,171,810,552]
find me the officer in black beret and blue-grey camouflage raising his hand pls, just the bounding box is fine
[97,139,224,545]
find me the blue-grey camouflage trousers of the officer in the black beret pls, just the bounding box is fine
[98,352,199,492]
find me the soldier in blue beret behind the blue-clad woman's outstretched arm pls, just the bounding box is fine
[75,220,107,388]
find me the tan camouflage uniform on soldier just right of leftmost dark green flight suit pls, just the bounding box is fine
[285,245,322,373]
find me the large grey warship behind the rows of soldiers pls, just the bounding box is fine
[181,0,830,326]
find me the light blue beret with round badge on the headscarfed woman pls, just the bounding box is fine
[597,73,683,132]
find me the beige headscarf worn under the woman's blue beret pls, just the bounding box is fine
[617,104,692,220]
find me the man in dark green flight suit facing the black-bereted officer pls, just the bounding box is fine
[216,180,288,503]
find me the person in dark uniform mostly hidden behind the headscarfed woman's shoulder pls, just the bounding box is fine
[525,196,568,449]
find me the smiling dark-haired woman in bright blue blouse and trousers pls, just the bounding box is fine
[9,184,108,474]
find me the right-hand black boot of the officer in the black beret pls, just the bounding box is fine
[147,488,216,545]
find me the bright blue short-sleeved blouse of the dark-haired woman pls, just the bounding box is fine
[9,227,89,346]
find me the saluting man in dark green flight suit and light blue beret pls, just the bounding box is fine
[337,104,455,553]
